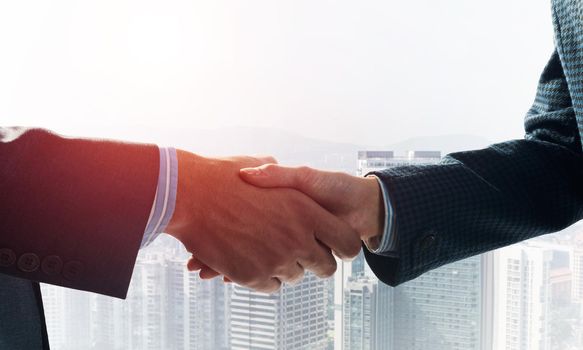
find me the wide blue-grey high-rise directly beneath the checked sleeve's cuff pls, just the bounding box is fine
[394,256,486,350]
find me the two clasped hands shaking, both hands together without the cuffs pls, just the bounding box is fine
[166,150,385,292]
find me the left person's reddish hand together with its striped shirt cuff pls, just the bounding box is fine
[142,148,360,292]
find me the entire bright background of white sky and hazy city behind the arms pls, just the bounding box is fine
[0,0,572,350]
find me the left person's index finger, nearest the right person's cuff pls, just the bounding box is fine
[309,207,362,260]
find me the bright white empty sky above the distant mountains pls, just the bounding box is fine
[0,0,553,145]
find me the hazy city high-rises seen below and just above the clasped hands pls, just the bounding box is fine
[42,139,583,350]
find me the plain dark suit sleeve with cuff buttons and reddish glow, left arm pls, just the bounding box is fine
[0,128,160,298]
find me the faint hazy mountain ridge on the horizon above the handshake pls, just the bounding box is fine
[68,126,489,172]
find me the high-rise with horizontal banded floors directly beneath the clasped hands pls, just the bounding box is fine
[230,273,328,350]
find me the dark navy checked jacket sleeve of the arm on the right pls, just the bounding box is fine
[364,53,583,285]
